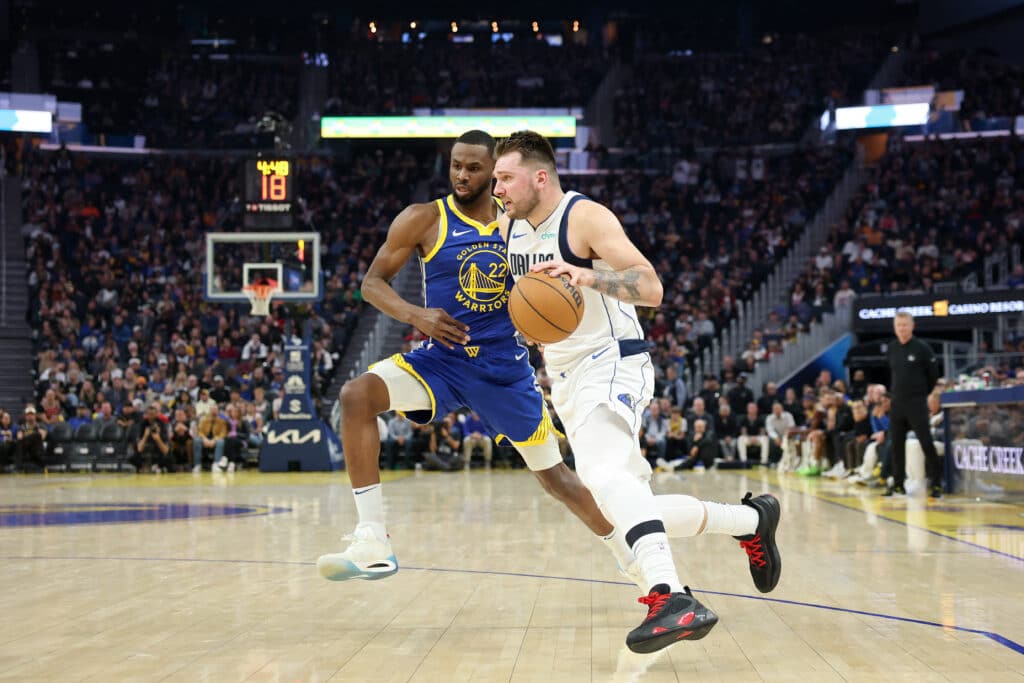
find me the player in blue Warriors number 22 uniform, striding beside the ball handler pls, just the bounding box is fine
[316,131,633,581]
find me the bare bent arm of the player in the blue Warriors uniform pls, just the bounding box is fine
[362,204,469,348]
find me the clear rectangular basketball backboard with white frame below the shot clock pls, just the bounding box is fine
[204,232,323,303]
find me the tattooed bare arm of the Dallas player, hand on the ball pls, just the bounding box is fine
[530,197,665,306]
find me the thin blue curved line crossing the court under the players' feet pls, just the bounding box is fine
[0,555,1024,654]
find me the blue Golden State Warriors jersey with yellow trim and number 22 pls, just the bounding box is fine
[422,195,515,352]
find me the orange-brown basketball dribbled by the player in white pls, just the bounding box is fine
[509,272,584,344]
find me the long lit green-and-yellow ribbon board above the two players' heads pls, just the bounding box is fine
[321,116,577,139]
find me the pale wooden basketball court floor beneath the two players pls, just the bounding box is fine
[0,471,1024,683]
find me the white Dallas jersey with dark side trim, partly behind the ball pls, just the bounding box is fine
[508,191,643,369]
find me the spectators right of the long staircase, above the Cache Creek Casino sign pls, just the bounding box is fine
[781,136,1024,319]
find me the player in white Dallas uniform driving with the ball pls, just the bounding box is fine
[495,131,781,652]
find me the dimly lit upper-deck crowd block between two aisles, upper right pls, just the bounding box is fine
[615,33,889,151]
